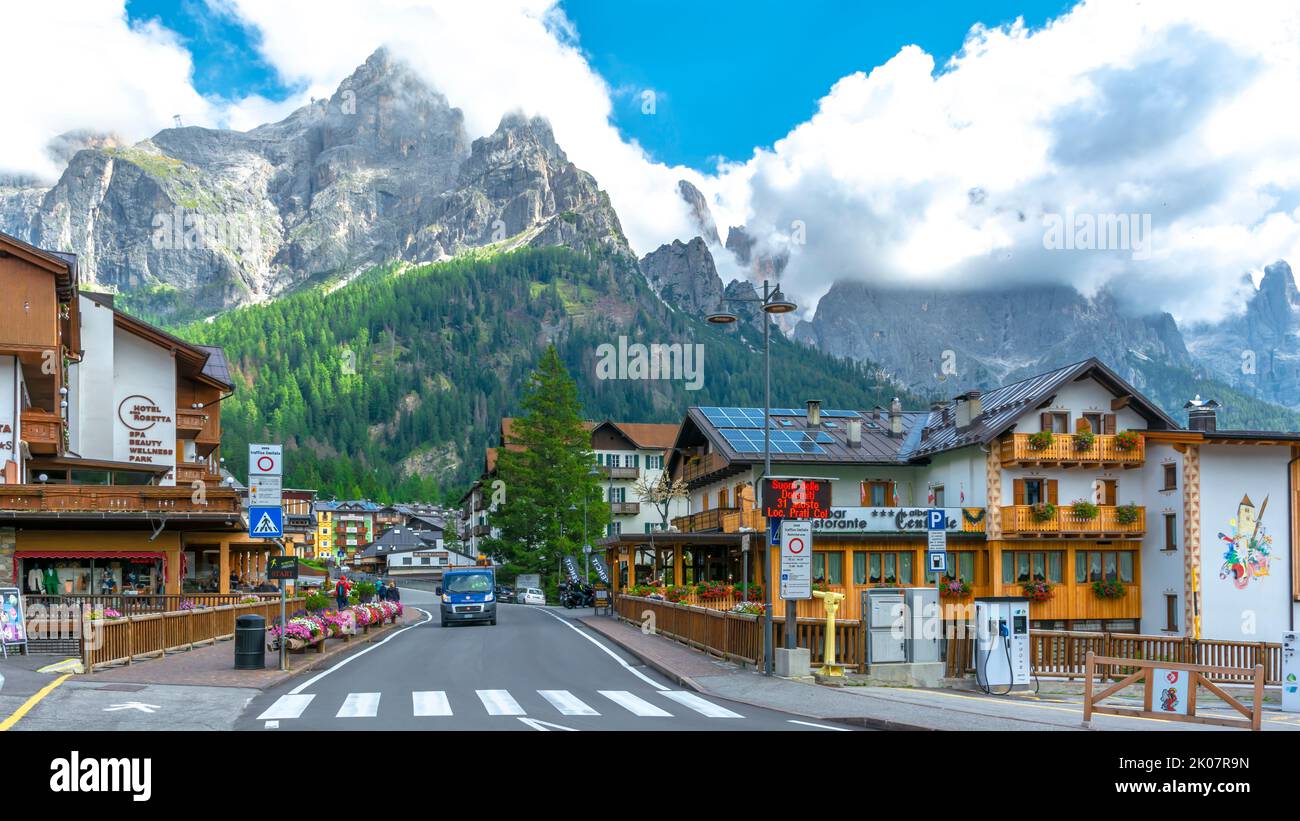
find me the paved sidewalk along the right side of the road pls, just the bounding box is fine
[579,616,1300,731]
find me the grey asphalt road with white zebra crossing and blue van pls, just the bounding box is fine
[235,588,852,731]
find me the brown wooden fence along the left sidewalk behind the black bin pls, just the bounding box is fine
[82,599,304,673]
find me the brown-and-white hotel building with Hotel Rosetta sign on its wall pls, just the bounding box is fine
[0,234,270,595]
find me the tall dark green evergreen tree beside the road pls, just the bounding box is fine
[489,346,610,574]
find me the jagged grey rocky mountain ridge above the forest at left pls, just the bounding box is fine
[0,49,631,316]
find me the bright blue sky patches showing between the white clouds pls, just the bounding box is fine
[126,0,1073,170]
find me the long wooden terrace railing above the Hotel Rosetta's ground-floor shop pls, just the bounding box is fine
[0,485,239,513]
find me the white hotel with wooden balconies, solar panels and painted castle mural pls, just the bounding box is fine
[602,359,1300,642]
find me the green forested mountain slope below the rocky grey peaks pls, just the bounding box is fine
[178,247,922,500]
